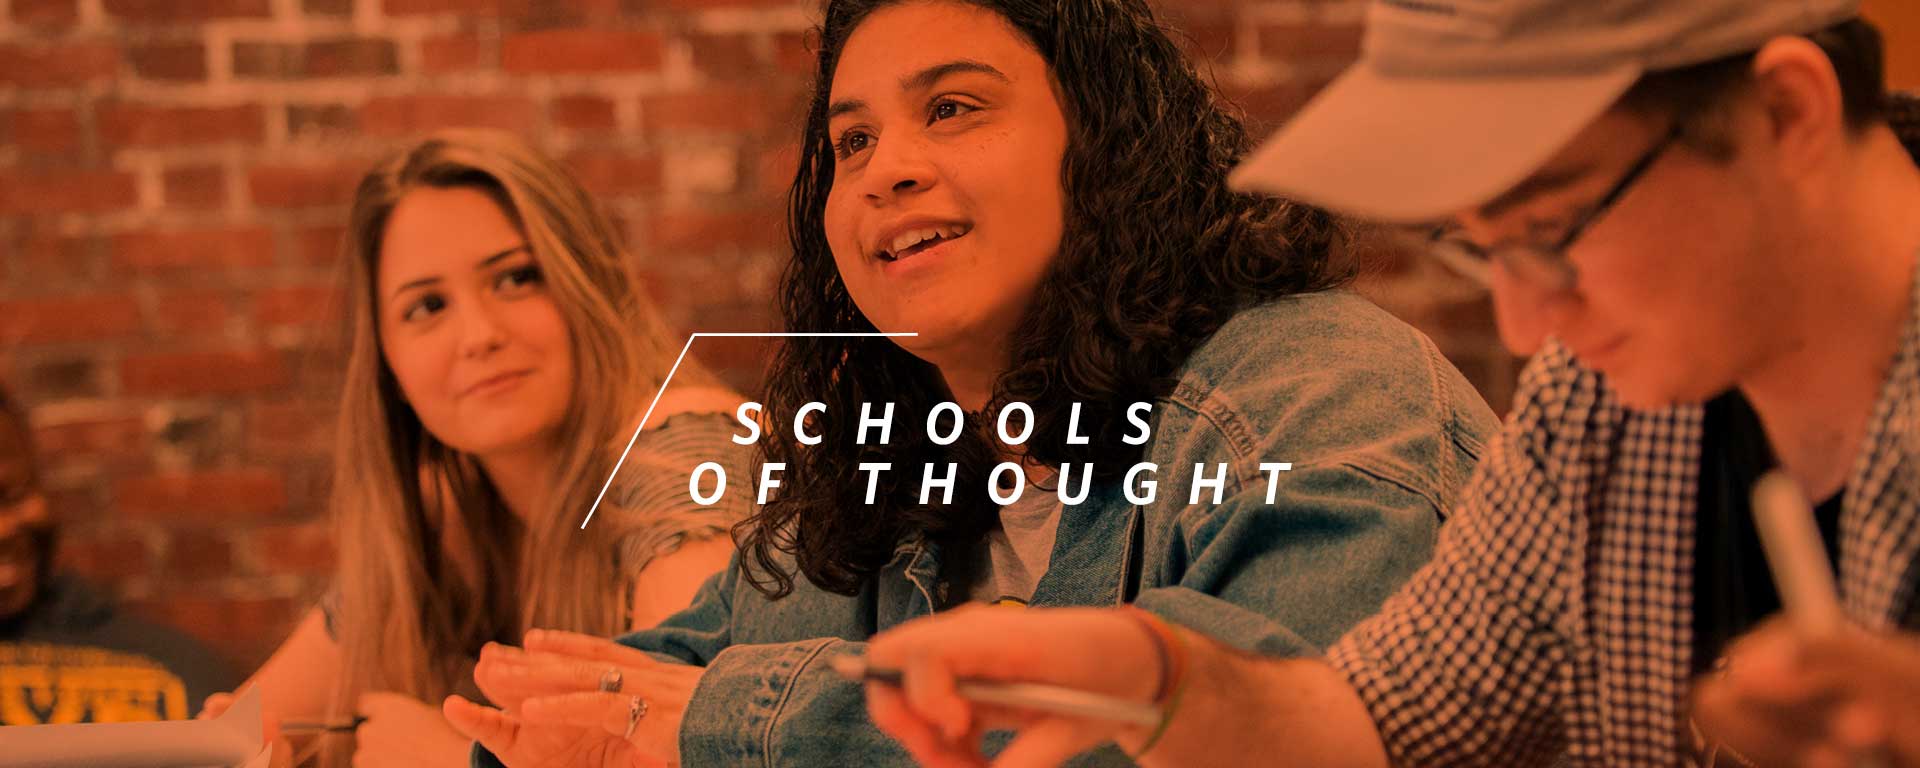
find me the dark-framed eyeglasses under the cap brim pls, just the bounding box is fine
[1427,123,1684,292]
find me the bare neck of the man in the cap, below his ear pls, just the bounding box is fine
[1740,131,1920,503]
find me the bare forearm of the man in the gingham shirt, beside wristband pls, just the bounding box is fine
[1119,632,1388,768]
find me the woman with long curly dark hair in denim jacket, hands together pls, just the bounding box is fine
[447,0,1494,766]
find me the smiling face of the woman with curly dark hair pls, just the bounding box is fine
[826,2,1068,378]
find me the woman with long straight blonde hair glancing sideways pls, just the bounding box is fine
[209,131,747,766]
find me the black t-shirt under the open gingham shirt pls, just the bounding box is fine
[1693,390,1839,674]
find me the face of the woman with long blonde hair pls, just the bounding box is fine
[376,186,574,457]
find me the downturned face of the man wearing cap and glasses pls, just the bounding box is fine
[1455,109,1797,409]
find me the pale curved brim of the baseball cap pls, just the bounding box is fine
[1231,61,1642,223]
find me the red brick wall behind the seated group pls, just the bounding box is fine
[0,0,1513,666]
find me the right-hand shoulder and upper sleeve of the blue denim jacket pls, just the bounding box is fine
[1137,292,1498,655]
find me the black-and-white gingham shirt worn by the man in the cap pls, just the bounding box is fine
[1331,261,1920,766]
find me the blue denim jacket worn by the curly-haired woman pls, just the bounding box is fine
[480,292,1496,766]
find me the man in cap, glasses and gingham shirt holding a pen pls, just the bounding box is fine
[868,0,1920,766]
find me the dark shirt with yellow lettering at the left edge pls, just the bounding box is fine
[0,576,240,726]
